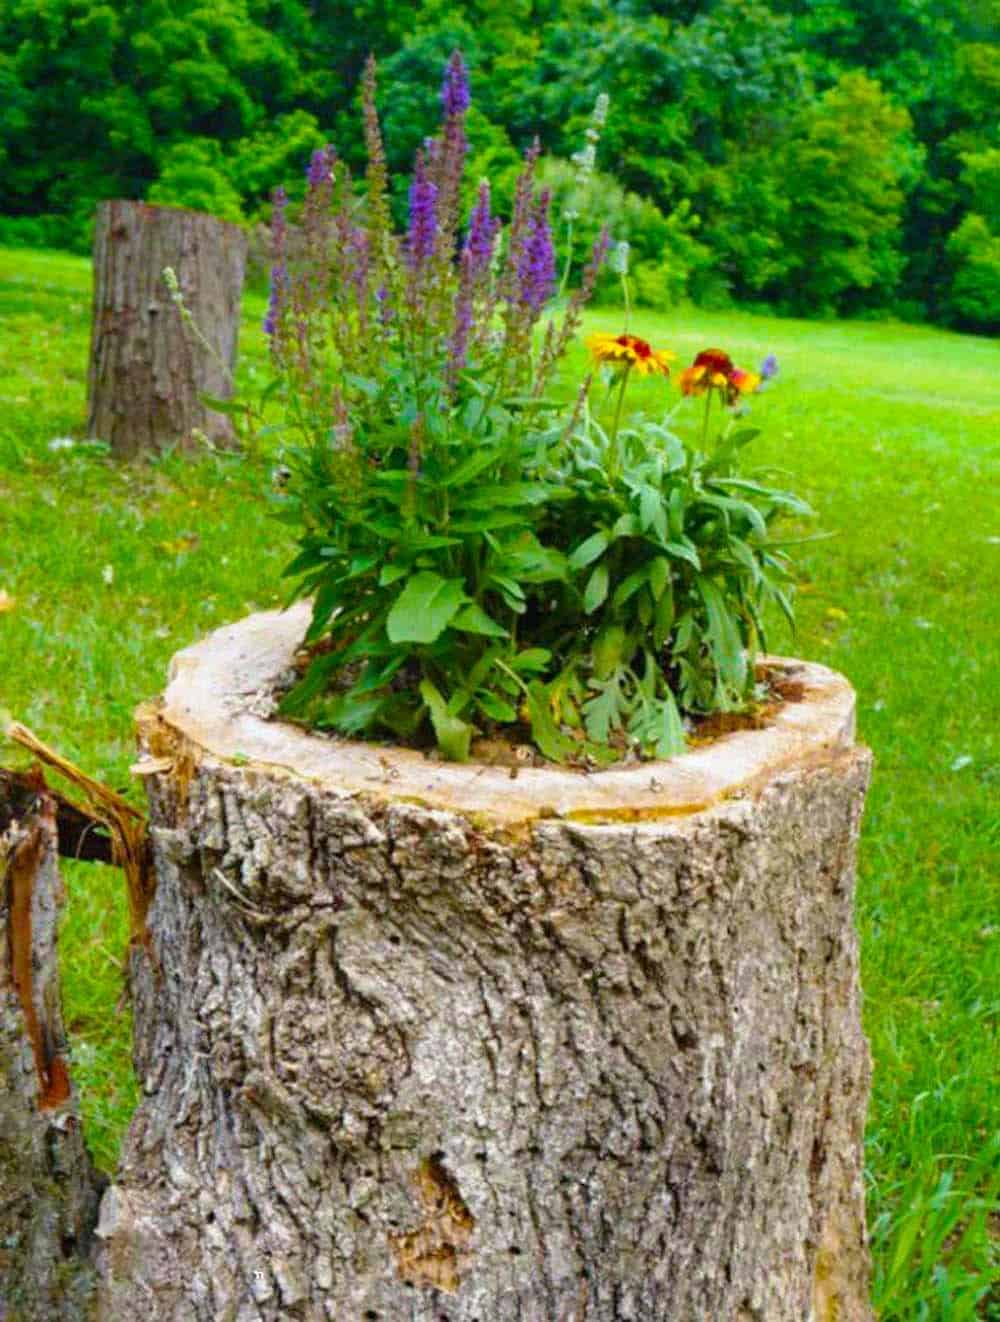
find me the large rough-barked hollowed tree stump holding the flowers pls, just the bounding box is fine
[98,607,872,1322]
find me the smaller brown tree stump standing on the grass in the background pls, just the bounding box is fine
[87,201,247,457]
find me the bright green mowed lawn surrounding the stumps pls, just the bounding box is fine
[0,251,1000,1319]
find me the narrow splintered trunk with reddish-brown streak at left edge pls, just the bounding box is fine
[0,780,99,1322]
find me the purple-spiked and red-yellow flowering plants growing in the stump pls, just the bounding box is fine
[240,53,808,764]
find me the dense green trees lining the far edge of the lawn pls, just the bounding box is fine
[0,0,1000,331]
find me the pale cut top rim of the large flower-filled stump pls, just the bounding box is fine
[150,602,854,826]
